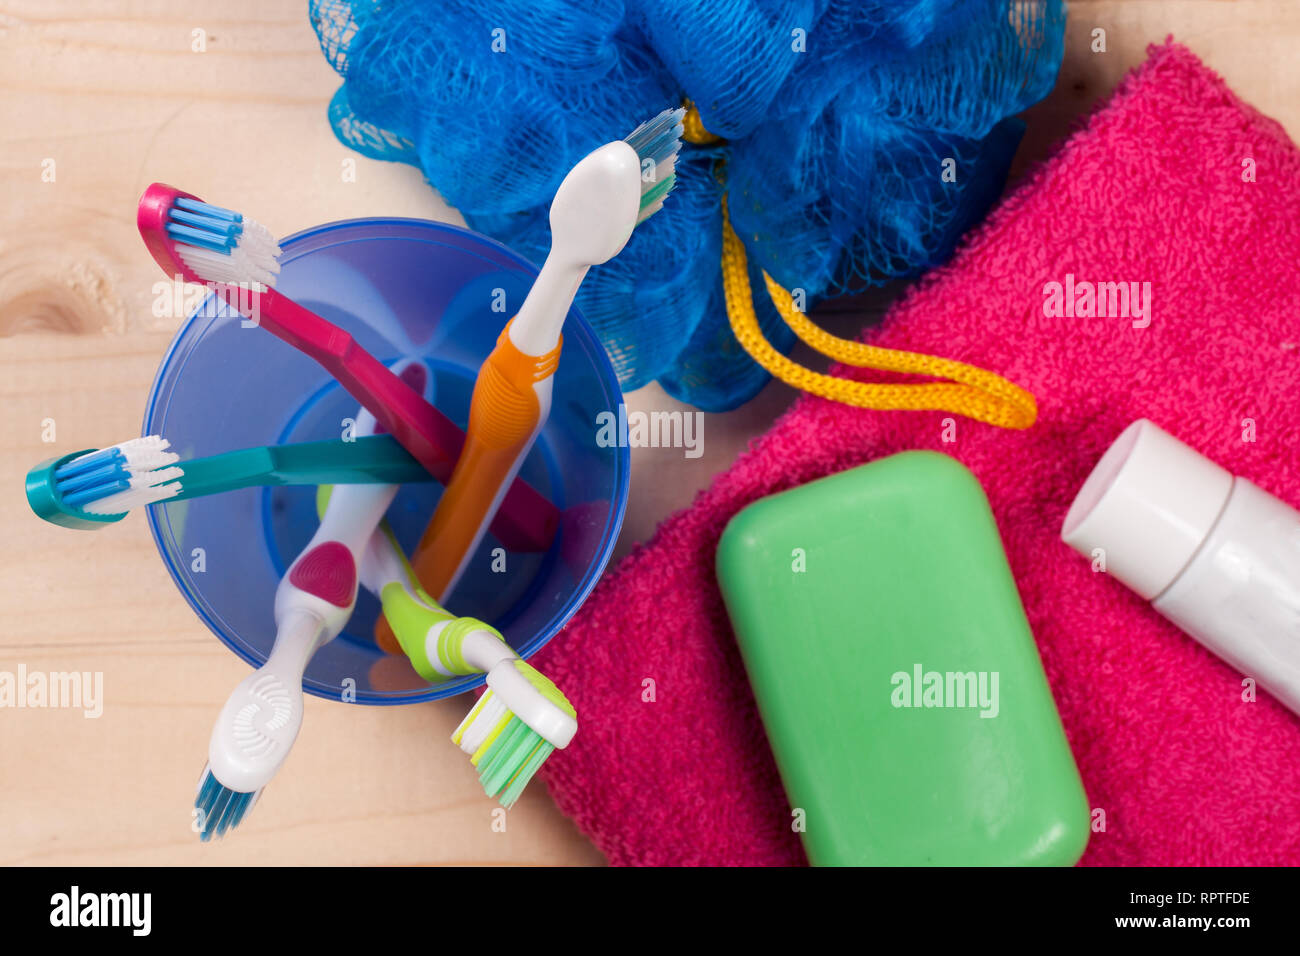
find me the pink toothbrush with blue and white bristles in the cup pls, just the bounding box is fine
[137,182,559,551]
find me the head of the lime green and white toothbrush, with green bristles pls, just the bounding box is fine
[451,658,577,809]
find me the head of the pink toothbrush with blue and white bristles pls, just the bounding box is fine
[135,182,280,291]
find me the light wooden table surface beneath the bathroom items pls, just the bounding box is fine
[0,0,1300,864]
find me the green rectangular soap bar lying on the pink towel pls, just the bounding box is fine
[718,451,1089,866]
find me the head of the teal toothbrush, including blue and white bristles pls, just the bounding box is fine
[27,434,185,529]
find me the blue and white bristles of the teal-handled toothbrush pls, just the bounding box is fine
[55,434,185,515]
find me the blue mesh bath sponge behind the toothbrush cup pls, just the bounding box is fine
[311,0,1065,411]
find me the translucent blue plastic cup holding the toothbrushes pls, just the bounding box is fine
[144,219,629,704]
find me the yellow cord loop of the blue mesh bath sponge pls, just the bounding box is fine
[723,196,1039,429]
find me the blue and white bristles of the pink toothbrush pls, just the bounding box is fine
[166,199,280,291]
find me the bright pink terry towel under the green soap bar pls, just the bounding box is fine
[540,43,1300,865]
